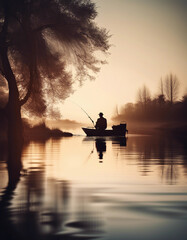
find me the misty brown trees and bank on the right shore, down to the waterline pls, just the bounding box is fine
[112,74,187,139]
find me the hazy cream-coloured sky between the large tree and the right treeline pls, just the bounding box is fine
[61,0,187,125]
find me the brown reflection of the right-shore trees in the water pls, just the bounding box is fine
[126,135,187,184]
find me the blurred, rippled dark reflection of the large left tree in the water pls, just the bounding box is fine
[0,138,103,240]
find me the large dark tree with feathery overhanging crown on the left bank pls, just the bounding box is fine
[0,0,109,148]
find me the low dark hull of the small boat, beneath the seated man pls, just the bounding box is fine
[82,128,126,136]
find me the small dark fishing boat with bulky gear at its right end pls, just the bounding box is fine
[82,123,128,136]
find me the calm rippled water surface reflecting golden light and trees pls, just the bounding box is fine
[0,135,187,240]
